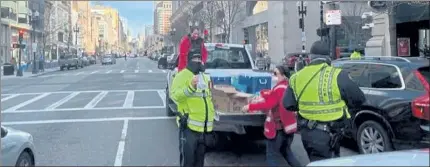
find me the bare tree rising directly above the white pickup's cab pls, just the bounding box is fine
[212,0,246,43]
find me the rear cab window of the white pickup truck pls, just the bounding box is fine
[206,47,252,69]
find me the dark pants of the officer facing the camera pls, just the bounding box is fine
[179,128,206,167]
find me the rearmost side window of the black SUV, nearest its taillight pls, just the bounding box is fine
[368,64,402,88]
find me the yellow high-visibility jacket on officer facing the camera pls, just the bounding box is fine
[169,69,215,132]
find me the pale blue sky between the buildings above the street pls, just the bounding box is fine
[92,1,154,37]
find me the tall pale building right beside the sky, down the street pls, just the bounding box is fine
[154,1,172,35]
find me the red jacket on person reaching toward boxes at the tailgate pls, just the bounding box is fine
[249,80,296,137]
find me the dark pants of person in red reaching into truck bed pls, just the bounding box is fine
[266,131,302,166]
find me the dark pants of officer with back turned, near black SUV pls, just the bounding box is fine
[300,128,340,161]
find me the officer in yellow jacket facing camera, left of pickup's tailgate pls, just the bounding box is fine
[169,54,215,167]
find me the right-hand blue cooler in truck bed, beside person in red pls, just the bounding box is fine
[239,72,272,94]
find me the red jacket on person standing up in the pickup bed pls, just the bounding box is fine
[178,35,208,71]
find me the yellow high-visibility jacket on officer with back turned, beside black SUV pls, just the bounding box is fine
[290,63,350,122]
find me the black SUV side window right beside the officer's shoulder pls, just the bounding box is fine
[342,63,370,87]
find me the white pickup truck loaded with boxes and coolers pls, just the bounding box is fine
[166,43,265,148]
